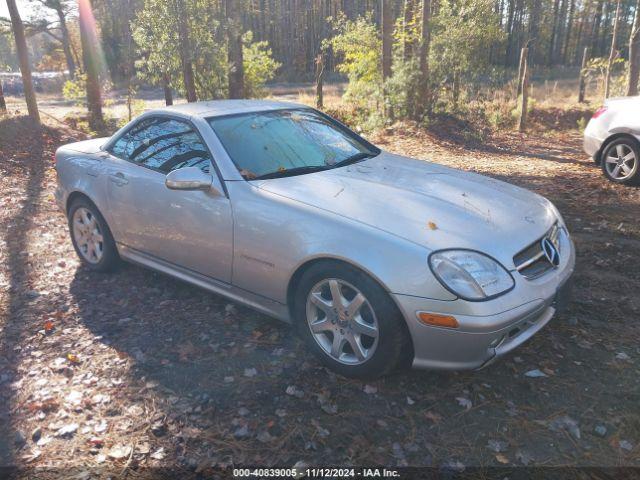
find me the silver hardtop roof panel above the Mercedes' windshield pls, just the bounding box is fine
[148,100,310,118]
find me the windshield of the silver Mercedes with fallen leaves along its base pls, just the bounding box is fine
[208,109,380,180]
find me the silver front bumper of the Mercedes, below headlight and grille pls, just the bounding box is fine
[394,237,575,370]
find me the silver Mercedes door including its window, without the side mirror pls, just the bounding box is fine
[107,116,233,283]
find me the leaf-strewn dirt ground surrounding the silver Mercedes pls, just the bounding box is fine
[0,112,640,476]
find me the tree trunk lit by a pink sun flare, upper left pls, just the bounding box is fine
[79,2,104,129]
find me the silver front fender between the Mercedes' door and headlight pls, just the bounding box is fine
[228,182,456,303]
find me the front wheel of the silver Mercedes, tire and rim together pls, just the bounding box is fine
[293,261,413,379]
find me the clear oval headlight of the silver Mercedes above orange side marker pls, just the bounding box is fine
[429,250,515,301]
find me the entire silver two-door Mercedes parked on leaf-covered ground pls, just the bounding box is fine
[56,101,575,377]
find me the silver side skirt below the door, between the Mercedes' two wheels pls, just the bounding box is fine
[118,243,291,323]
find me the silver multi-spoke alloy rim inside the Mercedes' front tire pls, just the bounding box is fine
[307,278,380,365]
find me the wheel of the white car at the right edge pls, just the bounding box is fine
[600,137,640,185]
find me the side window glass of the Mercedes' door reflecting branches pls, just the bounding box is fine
[109,117,213,174]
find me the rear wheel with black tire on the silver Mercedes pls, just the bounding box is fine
[67,198,120,272]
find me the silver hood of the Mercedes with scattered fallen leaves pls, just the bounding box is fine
[253,152,556,269]
